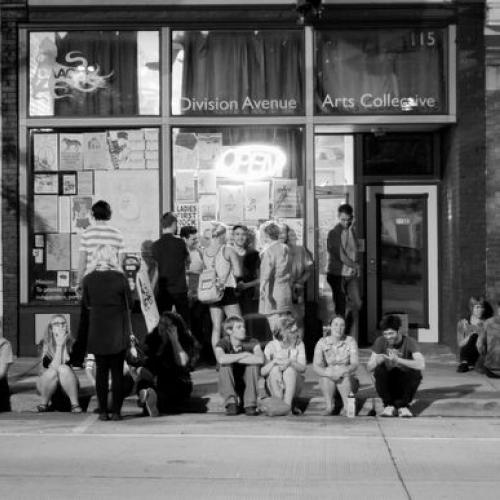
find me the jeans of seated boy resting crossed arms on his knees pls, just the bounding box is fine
[219,363,260,408]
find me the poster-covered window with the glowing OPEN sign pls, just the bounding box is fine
[173,127,304,244]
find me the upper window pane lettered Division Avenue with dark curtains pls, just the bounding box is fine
[172,30,304,115]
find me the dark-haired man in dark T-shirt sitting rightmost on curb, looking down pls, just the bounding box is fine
[367,315,425,417]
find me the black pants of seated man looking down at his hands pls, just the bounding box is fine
[373,363,422,408]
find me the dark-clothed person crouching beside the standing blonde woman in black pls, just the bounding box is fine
[137,311,194,417]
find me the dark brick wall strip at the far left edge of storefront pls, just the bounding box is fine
[0,2,26,352]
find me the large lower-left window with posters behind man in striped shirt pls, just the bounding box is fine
[29,128,159,301]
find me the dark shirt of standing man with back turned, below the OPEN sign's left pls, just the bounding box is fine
[152,233,189,293]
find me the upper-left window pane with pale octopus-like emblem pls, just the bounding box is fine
[29,30,160,117]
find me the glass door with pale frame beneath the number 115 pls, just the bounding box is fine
[366,186,438,342]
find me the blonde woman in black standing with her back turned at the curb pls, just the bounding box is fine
[82,245,132,420]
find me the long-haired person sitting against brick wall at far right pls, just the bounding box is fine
[457,296,485,373]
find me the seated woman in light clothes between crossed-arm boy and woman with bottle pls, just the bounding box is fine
[261,320,306,415]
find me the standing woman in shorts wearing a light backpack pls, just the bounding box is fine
[203,223,241,353]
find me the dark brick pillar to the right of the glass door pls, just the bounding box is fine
[440,2,484,348]
